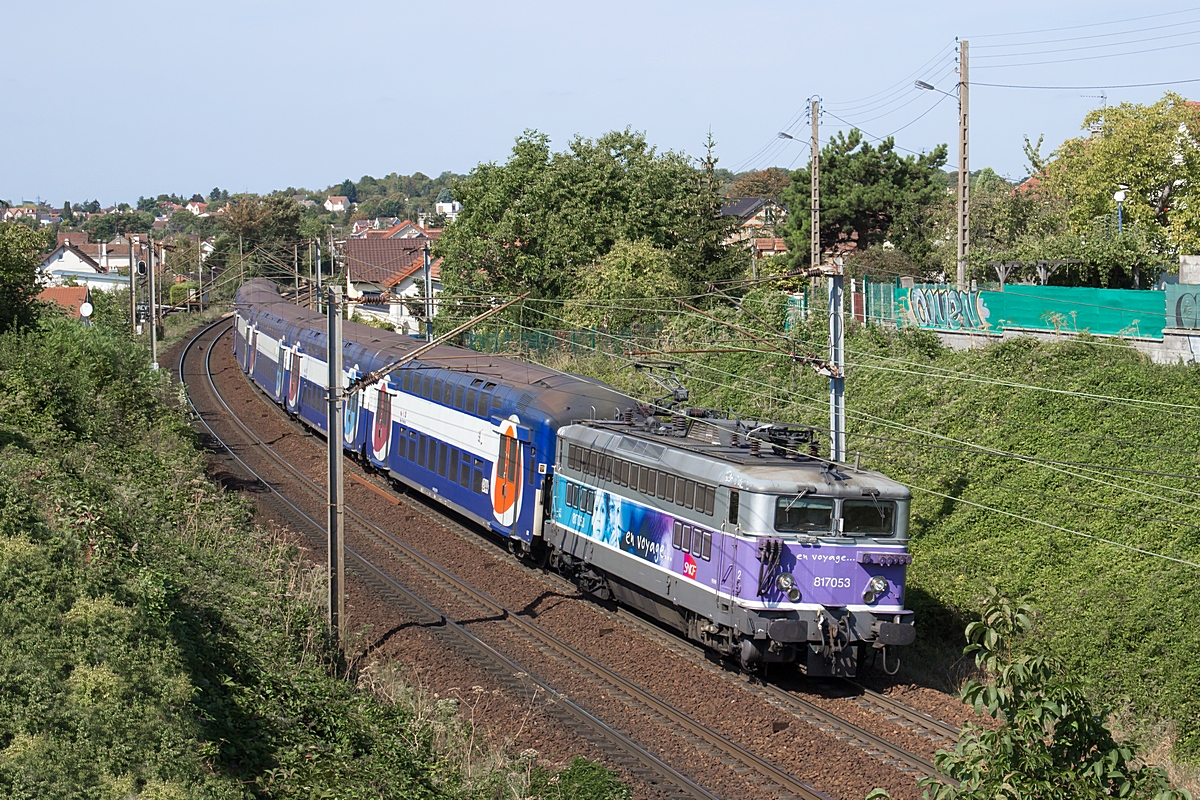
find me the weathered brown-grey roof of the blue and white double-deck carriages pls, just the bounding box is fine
[231,278,636,428]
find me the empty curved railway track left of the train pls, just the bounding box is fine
[179,320,828,800]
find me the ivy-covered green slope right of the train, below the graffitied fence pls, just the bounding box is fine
[561,293,1200,760]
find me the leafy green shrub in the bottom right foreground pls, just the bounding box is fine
[869,590,1190,800]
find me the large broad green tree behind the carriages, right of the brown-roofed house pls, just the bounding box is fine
[434,128,727,300]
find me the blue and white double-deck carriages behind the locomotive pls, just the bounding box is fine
[234,279,632,548]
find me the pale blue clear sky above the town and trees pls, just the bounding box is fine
[0,0,1200,205]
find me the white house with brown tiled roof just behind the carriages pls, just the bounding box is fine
[346,237,442,333]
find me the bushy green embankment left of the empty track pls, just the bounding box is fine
[0,319,626,799]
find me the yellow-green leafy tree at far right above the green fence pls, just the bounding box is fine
[1040,92,1200,255]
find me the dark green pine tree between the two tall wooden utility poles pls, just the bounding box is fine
[782,128,947,266]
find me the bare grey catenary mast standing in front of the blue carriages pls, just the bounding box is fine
[325,284,346,651]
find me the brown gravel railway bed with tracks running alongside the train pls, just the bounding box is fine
[180,320,956,798]
